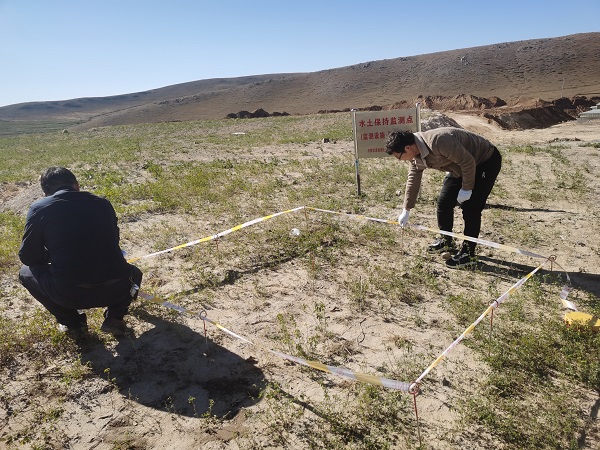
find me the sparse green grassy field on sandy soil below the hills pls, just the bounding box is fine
[0,114,600,449]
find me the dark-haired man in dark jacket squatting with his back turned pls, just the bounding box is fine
[19,167,142,336]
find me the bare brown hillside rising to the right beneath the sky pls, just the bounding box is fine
[0,33,600,128]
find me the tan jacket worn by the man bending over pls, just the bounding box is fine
[403,127,496,209]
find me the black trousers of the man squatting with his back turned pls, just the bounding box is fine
[19,264,142,328]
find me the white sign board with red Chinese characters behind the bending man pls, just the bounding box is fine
[352,105,421,159]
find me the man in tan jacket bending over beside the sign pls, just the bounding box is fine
[386,127,502,268]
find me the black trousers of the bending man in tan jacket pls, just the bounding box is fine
[437,149,502,256]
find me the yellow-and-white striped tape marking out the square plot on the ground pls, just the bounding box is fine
[128,206,577,394]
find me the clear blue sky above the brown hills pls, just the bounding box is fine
[0,0,600,106]
